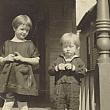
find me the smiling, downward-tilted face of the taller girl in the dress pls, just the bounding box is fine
[14,24,30,40]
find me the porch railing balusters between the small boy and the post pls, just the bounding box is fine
[79,70,96,110]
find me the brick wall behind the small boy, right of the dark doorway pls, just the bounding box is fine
[46,0,76,98]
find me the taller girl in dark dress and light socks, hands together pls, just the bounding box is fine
[0,15,40,110]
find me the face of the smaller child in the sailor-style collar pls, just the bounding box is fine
[62,42,76,58]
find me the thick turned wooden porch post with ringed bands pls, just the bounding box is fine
[96,0,110,110]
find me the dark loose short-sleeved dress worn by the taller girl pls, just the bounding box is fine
[0,40,39,95]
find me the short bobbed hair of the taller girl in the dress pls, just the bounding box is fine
[12,15,32,29]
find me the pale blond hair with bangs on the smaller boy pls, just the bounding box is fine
[60,32,80,48]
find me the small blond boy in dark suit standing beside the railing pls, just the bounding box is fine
[49,33,86,110]
